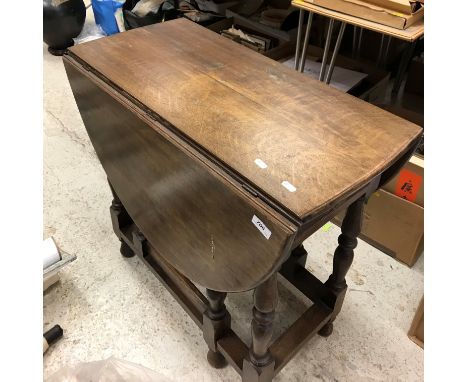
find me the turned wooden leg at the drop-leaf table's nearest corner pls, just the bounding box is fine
[242,273,278,382]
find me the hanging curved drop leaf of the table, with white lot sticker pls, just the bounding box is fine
[64,59,294,292]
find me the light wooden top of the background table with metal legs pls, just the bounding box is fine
[291,0,424,42]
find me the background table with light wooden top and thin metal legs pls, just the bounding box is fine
[291,0,424,93]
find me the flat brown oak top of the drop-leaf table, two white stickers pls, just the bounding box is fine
[70,19,421,218]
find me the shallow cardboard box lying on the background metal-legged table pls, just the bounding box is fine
[305,0,424,29]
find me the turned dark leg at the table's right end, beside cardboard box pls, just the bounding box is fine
[318,196,365,337]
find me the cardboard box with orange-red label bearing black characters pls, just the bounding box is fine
[382,155,424,207]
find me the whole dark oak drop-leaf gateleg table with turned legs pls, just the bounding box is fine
[64,19,421,381]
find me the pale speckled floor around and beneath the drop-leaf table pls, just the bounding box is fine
[44,33,423,382]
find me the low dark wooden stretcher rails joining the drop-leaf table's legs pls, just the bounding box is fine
[111,198,338,376]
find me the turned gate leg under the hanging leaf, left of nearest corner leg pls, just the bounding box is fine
[203,289,231,369]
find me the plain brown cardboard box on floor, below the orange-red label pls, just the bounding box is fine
[332,190,424,266]
